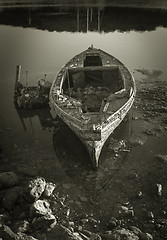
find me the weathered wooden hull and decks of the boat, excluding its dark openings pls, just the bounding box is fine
[50,48,136,167]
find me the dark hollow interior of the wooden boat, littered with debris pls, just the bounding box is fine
[62,53,125,113]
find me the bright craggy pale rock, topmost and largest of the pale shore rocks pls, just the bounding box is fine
[24,177,46,202]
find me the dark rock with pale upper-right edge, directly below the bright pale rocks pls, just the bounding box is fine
[32,214,57,232]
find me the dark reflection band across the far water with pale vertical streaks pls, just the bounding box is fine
[0,5,167,32]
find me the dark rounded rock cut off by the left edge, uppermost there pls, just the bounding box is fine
[0,172,19,188]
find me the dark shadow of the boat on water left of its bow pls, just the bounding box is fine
[53,117,93,177]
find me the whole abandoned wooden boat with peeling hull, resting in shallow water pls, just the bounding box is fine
[50,46,136,167]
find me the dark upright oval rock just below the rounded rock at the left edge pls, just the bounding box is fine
[2,187,20,211]
